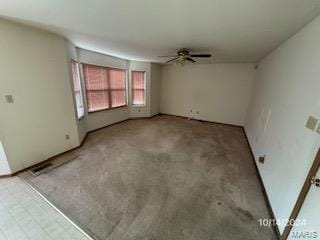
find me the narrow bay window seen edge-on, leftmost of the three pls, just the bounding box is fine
[71,60,84,119]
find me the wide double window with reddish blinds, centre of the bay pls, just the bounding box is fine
[83,64,126,112]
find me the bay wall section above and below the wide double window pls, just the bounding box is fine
[77,49,129,131]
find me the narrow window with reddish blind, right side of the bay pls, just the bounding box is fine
[131,71,146,105]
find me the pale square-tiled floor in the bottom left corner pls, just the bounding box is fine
[0,177,92,240]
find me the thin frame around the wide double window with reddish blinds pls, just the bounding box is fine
[80,62,128,114]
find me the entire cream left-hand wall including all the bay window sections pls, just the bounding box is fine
[0,20,164,175]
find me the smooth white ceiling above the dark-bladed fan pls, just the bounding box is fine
[0,0,320,62]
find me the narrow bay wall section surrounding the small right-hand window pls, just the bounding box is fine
[129,61,151,118]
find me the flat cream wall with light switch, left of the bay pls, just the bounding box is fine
[0,20,79,172]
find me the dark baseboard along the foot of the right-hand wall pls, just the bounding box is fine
[242,127,281,239]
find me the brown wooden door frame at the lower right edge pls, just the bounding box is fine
[280,148,320,240]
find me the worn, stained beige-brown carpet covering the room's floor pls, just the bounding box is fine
[20,115,276,240]
